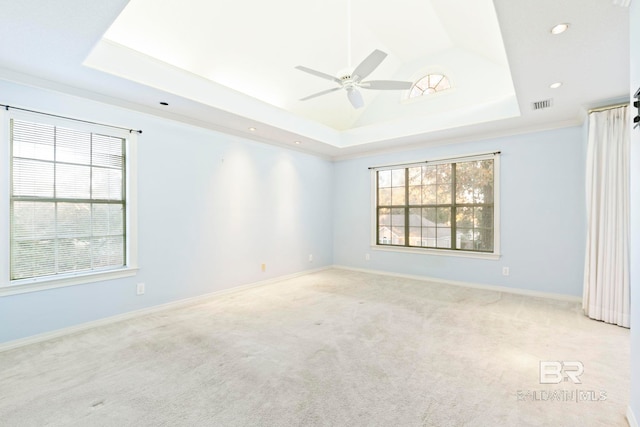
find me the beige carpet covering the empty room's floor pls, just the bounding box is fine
[0,270,629,426]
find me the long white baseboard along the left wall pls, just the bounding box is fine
[0,266,332,353]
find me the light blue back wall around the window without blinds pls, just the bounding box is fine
[334,127,586,296]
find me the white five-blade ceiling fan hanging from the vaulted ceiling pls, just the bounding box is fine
[295,49,413,108]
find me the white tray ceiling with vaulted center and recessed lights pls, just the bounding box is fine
[0,0,629,158]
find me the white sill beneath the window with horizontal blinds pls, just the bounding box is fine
[0,267,138,297]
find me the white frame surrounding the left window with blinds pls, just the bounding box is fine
[0,110,138,296]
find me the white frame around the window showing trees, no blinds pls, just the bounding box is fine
[369,151,501,260]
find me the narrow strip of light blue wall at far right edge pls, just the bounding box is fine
[629,0,640,423]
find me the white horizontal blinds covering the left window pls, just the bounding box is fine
[11,119,126,280]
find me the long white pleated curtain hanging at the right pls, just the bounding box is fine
[582,106,630,328]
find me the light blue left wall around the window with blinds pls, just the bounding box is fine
[0,81,333,342]
